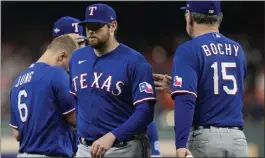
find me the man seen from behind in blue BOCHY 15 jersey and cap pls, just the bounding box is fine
[153,1,248,157]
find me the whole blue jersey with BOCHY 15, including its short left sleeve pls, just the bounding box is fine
[172,33,246,127]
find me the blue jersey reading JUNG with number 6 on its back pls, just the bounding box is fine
[10,63,74,157]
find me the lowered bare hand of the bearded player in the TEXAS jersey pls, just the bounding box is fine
[91,132,116,158]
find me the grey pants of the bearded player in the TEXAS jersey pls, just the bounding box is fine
[76,136,151,158]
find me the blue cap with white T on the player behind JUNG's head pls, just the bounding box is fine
[52,16,86,39]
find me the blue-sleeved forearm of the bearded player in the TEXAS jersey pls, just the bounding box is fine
[112,101,154,142]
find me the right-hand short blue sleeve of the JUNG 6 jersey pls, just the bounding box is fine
[52,68,75,115]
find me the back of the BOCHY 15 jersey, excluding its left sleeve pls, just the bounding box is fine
[191,33,246,127]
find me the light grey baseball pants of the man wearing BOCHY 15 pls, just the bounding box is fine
[188,127,248,157]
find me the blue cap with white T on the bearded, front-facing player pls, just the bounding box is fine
[79,4,117,25]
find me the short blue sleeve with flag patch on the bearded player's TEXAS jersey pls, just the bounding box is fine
[130,62,156,105]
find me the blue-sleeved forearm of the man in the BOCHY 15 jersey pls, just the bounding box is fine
[174,94,196,149]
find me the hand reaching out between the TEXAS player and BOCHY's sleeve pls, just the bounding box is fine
[153,74,172,93]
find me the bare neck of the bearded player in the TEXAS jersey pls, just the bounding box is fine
[94,38,119,57]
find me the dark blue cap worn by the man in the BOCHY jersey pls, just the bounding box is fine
[180,1,221,15]
